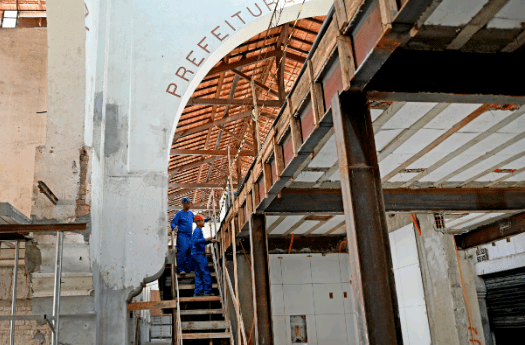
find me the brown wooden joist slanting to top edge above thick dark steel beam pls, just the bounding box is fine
[447,0,509,50]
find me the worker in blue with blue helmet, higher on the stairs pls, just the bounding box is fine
[171,198,194,275]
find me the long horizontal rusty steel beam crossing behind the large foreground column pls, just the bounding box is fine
[264,188,525,214]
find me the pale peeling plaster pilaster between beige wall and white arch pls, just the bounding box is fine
[32,0,85,222]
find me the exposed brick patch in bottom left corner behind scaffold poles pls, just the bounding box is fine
[0,300,51,345]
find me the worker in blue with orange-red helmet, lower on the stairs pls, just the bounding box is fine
[191,214,217,296]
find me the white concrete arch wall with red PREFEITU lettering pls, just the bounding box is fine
[84,0,333,344]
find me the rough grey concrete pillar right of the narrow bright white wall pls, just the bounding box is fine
[416,214,486,345]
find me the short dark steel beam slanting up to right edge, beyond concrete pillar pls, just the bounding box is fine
[454,212,525,249]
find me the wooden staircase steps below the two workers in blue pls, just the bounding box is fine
[172,254,233,345]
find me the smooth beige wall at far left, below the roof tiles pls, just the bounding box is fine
[0,28,47,217]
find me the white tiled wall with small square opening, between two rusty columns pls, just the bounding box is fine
[270,254,357,345]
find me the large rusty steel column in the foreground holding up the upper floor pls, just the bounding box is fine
[332,92,403,345]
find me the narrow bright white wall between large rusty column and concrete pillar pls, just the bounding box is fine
[389,225,431,345]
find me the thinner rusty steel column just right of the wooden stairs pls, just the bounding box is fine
[250,214,273,345]
